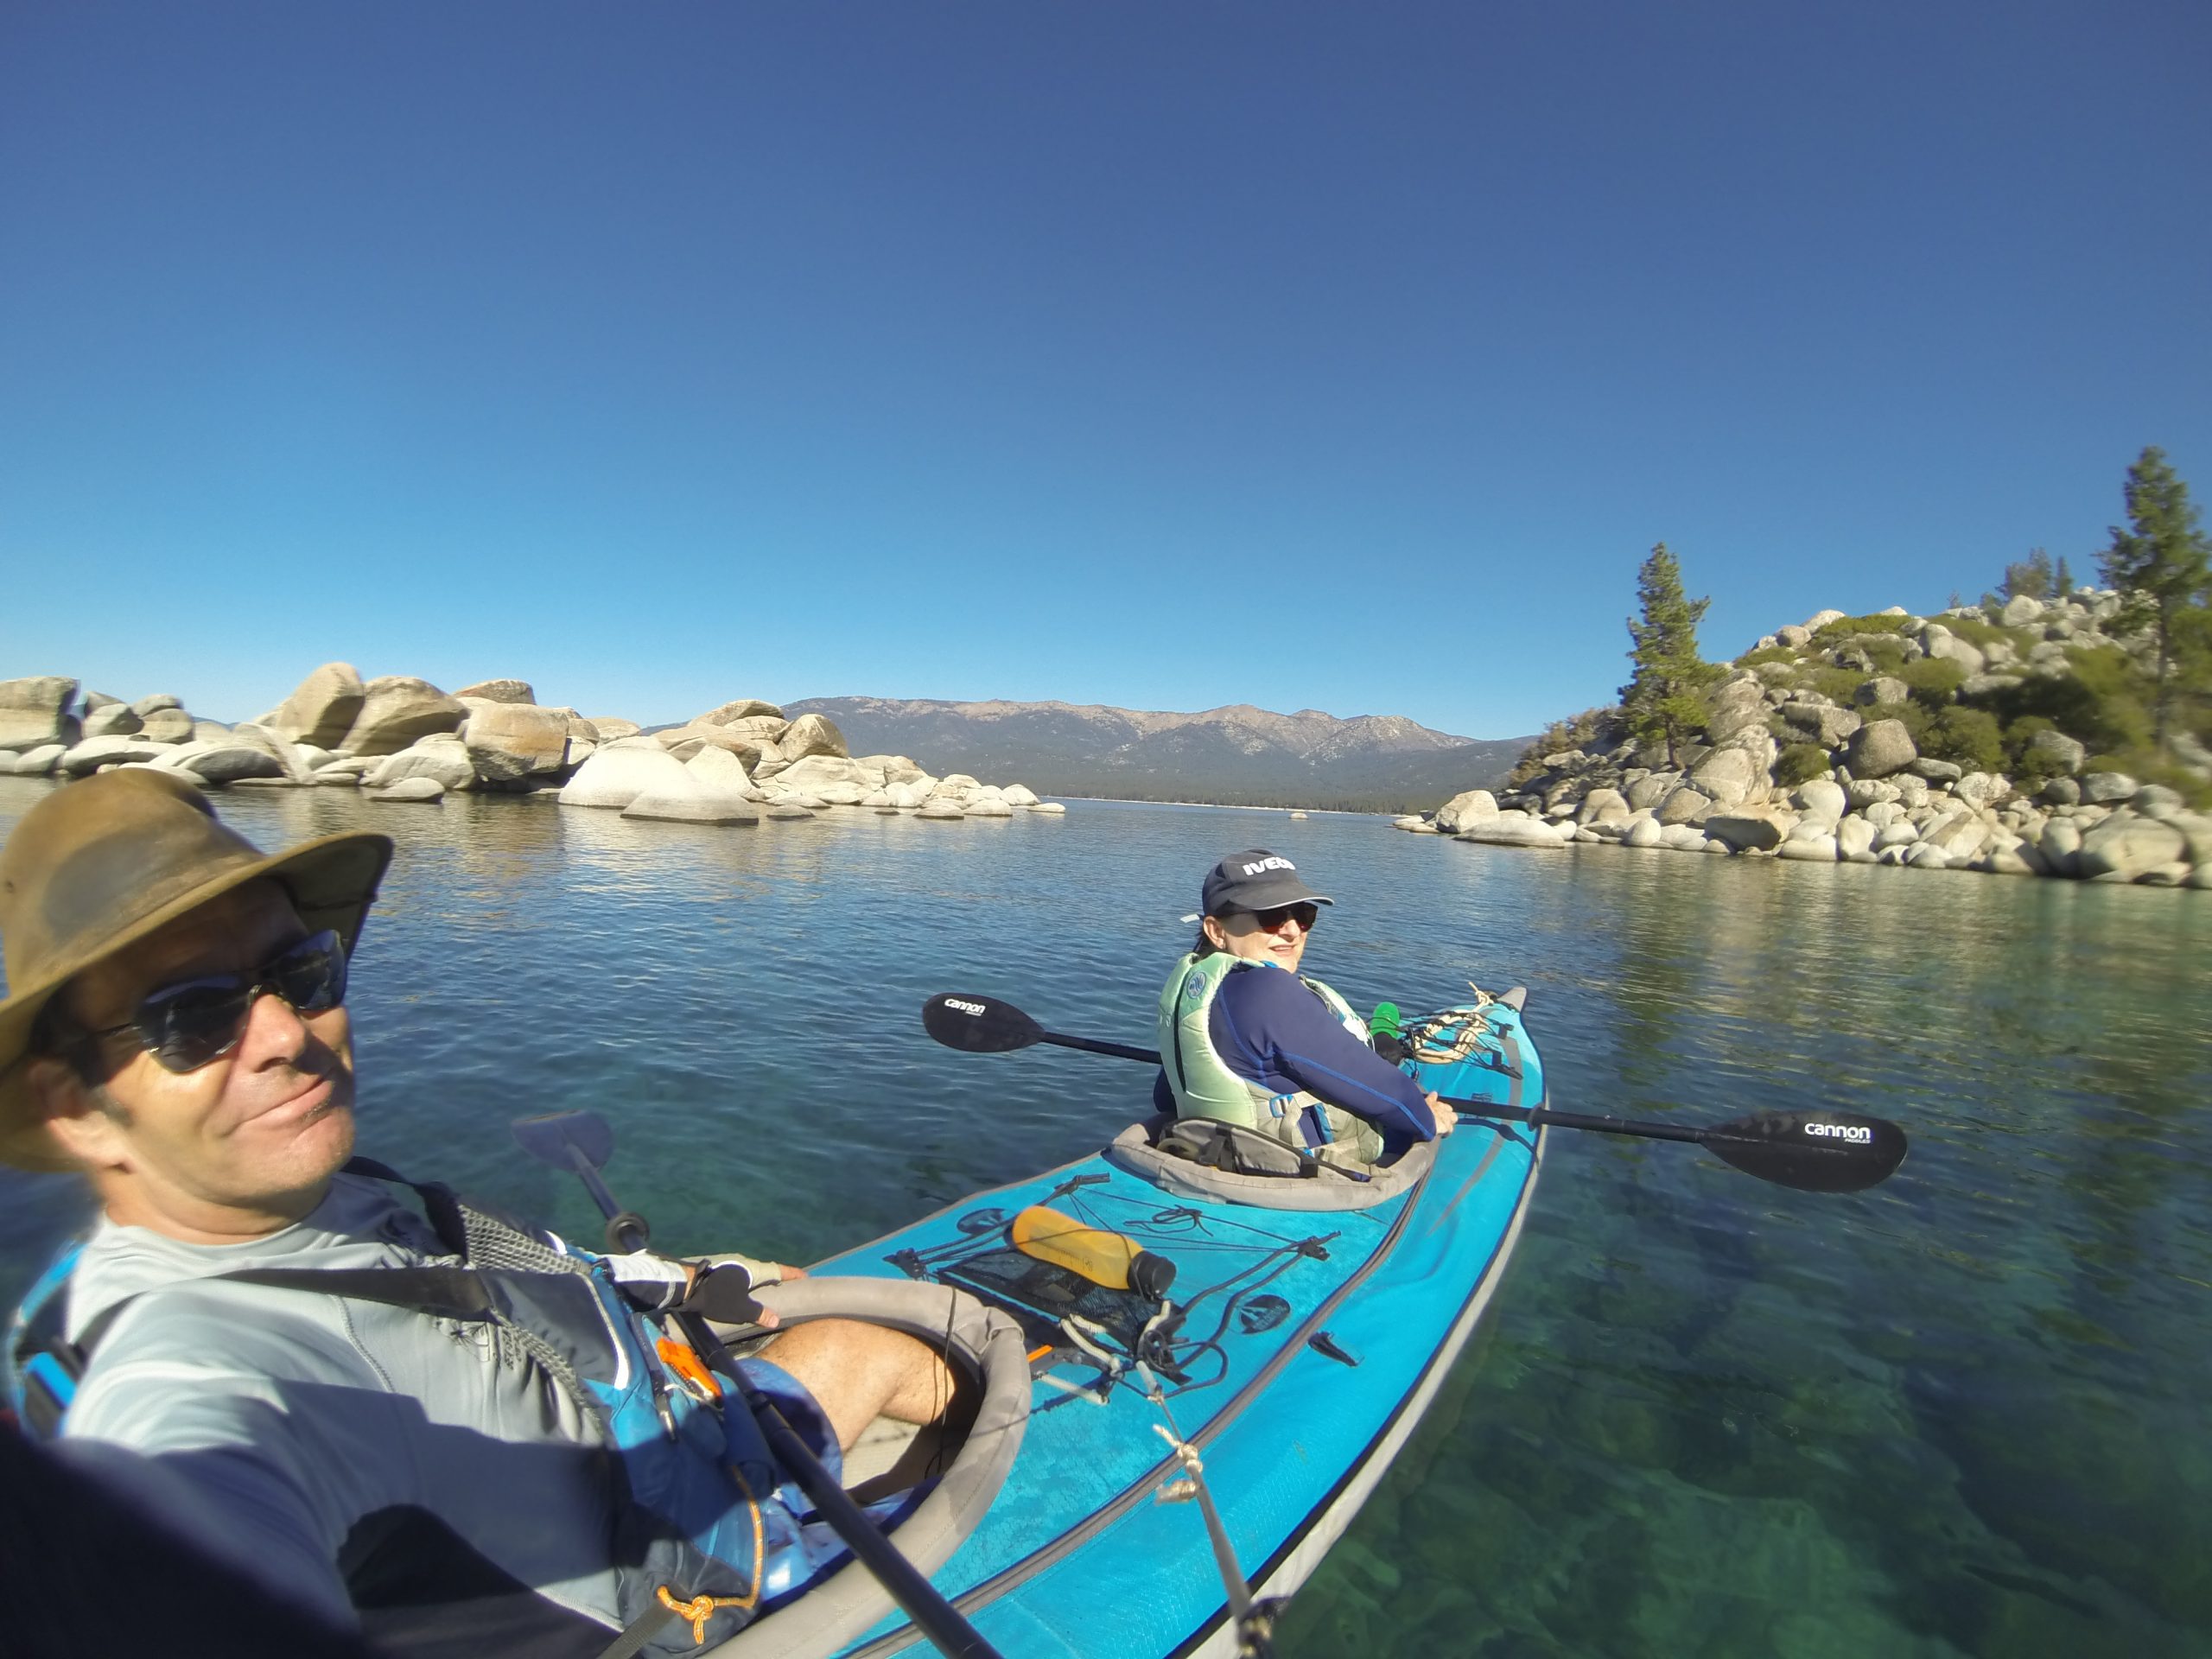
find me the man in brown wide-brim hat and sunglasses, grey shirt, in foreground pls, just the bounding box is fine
[0,767,953,1655]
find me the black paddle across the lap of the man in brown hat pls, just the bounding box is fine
[515,1119,1000,1659]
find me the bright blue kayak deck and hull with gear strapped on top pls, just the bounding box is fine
[730,993,1544,1659]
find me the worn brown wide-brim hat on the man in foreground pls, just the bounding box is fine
[0,767,391,1170]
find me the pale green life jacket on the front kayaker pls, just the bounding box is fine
[1159,951,1382,1168]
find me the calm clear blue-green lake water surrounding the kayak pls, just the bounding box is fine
[0,779,2212,1659]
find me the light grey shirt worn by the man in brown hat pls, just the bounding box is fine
[60,1174,637,1626]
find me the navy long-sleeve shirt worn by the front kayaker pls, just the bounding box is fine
[1153,963,1435,1157]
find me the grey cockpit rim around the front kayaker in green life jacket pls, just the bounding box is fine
[1103,1115,1435,1210]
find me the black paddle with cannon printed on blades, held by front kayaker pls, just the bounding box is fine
[923,991,1907,1192]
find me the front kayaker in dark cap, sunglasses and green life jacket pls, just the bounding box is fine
[1153,847,1458,1170]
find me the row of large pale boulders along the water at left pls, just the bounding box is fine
[0,661,1066,825]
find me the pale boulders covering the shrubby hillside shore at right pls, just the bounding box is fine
[1395,591,2212,889]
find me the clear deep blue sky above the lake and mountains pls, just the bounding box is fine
[0,0,2212,736]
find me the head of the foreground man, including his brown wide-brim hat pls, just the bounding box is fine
[0,770,391,1194]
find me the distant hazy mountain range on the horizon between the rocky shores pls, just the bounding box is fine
[785,696,1531,812]
